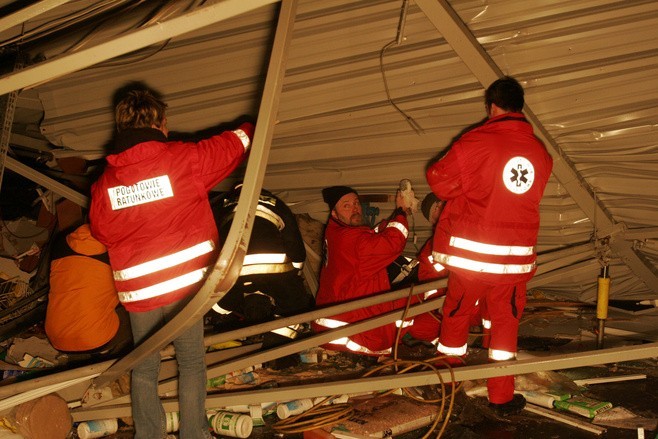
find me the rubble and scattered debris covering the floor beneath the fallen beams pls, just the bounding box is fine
[0,266,658,439]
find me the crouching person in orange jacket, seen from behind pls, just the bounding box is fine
[45,224,132,357]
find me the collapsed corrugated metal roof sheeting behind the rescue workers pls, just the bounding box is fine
[0,0,658,312]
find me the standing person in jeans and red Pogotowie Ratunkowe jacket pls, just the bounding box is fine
[90,90,253,439]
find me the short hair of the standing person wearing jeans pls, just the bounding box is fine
[114,90,167,131]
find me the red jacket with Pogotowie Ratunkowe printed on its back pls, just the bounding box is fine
[89,124,253,312]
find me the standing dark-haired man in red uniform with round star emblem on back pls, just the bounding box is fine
[427,77,553,415]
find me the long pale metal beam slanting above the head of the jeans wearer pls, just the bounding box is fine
[0,0,278,95]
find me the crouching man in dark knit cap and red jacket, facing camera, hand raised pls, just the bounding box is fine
[313,186,438,355]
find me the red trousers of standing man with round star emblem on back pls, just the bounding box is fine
[439,272,526,404]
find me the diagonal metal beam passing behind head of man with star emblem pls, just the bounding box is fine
[416,0,658,291]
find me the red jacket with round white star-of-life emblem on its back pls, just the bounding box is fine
[427,113,553,284]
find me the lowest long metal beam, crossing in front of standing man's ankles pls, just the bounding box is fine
[71,343,658,422]
